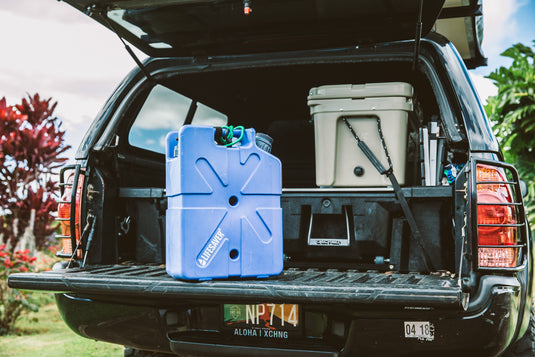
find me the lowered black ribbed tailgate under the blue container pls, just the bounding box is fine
[8,265,464,309]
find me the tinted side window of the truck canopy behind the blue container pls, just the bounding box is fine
[128,84,228,154]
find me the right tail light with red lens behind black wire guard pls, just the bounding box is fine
[476,163,524,268]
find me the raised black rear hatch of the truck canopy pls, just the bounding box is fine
[64,0,444,57]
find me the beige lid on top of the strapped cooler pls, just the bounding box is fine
[308,82,413,101]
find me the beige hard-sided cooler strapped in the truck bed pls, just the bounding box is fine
[308,82,413,187]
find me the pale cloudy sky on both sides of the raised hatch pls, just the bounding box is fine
[0,0,535,157]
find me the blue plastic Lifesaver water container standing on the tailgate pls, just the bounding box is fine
[166,125,283,280]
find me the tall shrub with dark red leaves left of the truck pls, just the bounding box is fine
[0,94,70,249]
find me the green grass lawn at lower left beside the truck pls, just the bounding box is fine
[0,292,123,357]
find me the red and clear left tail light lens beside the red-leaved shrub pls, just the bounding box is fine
[58,172,83,258]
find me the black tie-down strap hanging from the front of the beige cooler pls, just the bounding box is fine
[342,117,434,271]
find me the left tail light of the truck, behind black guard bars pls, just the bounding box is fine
[56,166,84,258]
